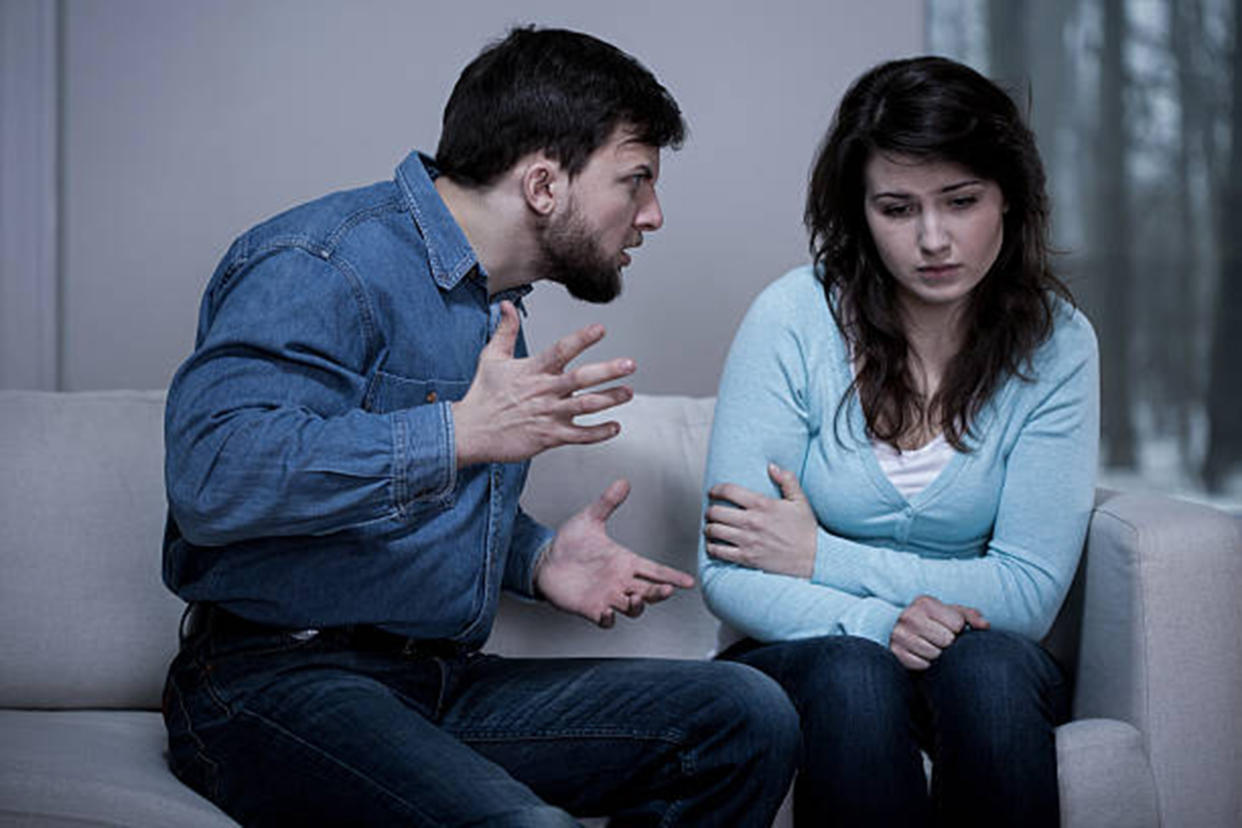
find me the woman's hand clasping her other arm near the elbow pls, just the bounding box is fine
[703,463,818,578]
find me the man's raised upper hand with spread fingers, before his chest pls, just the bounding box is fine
[452,302,635,468]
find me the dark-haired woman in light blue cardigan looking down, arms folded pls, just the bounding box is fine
[699,57,1099,826]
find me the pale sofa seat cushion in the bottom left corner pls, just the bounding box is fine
[0,710,236,828]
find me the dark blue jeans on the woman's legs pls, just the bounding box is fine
[722,631,1069,828]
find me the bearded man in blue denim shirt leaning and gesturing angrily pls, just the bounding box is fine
[164,29,799,826]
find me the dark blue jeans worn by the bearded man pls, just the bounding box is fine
[164,608,799,826]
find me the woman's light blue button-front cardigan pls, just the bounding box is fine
[699,267,1099,647]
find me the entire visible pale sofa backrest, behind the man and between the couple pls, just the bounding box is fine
[0,391,1081,709]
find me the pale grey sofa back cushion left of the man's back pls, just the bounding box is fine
[0,391,181,709]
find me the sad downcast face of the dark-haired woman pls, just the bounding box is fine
[863,153,1006,314]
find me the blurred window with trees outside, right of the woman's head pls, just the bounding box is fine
[927,0,1242,509]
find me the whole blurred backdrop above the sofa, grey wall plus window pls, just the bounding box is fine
[0,0,1242,510]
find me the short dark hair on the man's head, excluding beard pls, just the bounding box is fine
[436,26,686,186]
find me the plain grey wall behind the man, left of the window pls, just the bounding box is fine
[50,0,923,395]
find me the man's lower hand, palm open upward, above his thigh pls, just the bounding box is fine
[534,480,694,628]
